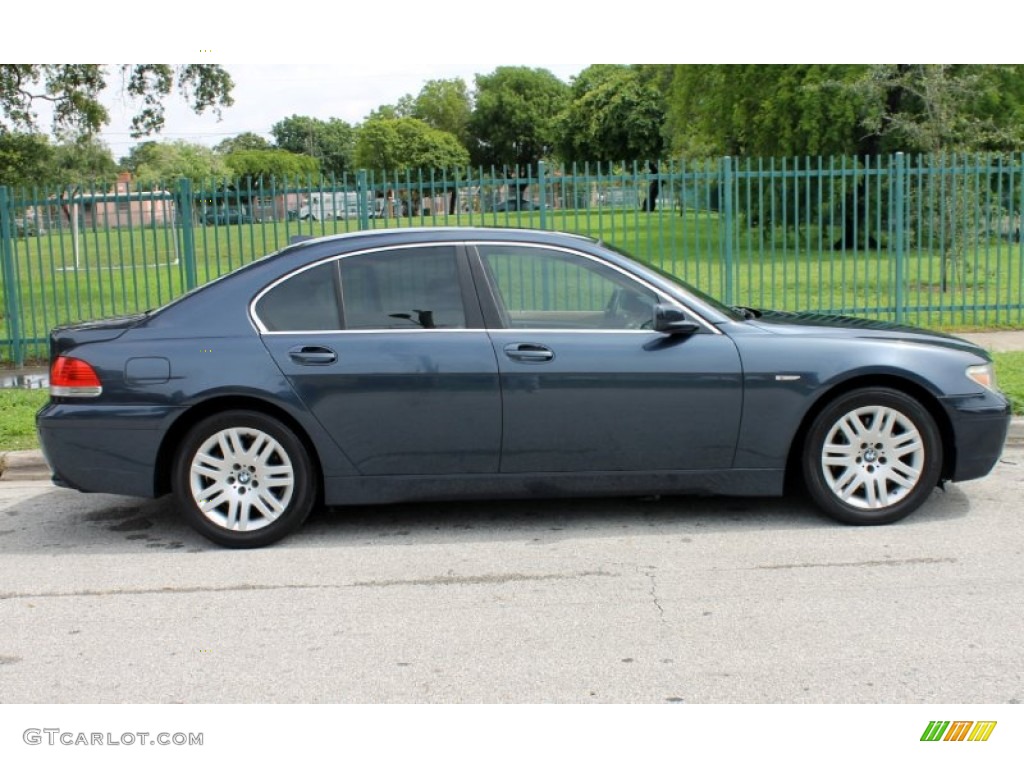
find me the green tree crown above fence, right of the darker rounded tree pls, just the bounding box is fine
[557,65,665,162]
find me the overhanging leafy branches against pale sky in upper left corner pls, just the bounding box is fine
[0,65,234,137]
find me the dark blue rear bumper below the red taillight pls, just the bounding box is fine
[36,401,177,498]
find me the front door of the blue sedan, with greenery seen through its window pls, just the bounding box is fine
[477,244,742,473]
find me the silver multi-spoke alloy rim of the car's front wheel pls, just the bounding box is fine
[821,406,925,510]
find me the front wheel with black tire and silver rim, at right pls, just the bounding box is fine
[802,387,942,525]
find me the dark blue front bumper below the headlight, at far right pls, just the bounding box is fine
[943,392,1013,482]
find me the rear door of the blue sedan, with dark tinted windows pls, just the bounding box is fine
[254,244,501,475]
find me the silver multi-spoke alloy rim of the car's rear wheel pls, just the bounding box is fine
[189,427,295,532]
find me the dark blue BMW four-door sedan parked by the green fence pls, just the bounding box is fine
[37,228,1010,548]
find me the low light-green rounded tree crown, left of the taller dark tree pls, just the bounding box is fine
[355,118,469,176]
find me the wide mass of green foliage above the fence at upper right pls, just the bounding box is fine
[663,65,1024,157]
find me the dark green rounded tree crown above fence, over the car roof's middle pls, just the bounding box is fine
[470,67,569,167]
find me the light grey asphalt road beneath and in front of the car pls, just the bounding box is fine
[0,446,1024,703]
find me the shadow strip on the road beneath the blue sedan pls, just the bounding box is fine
[0,485,971,554]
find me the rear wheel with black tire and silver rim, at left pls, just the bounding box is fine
[173,411,316,549]
